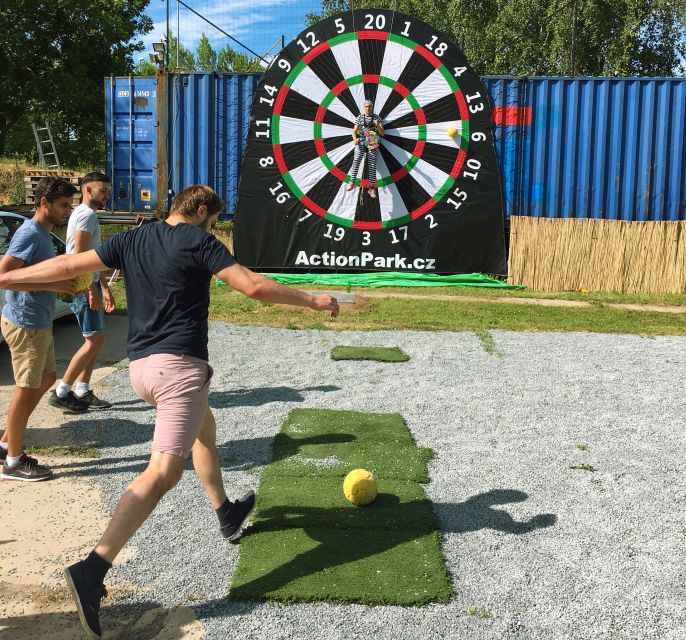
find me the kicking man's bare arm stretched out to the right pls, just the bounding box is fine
[215,264,339,318]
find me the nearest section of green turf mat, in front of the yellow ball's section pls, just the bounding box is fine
[230,527,452,606]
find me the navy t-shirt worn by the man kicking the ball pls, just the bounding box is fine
[95,222,236,360]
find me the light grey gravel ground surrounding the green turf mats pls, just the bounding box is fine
[72,323,686,640]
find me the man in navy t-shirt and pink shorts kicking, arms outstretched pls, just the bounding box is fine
[0,185,338,638]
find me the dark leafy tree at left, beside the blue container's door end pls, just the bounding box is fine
[0,0,152,154]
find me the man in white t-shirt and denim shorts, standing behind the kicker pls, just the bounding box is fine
[48,171,115,413]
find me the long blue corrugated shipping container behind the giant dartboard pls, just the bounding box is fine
[107,73,686,221]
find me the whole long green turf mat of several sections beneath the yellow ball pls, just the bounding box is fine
[230,409,453,605]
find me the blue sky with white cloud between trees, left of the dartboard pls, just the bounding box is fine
[140,0,321,62]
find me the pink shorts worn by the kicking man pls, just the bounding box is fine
[129,353,213,458]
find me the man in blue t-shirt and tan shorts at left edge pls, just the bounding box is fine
[0,178,76,482]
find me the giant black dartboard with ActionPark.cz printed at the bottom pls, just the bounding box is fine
[235,10,505,273]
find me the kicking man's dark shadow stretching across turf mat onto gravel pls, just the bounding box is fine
[230,489,557,600]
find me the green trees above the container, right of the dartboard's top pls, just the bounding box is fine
[307,0,686,76]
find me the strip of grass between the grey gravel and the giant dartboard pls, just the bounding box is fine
[107,279,686,336]
